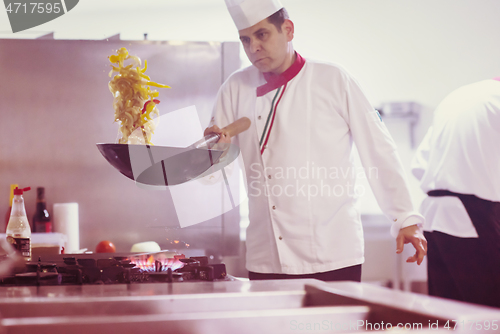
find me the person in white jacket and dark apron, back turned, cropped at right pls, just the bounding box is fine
[412,78,500,307]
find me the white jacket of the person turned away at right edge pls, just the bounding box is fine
[412,80,500,238]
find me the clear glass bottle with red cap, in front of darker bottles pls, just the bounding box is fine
[5,187,31,261]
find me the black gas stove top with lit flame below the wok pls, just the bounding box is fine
[0,253,227,286]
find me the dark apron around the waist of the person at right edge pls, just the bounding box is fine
[425,190,500,307]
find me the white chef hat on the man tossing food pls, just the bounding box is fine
[225,0,283,30]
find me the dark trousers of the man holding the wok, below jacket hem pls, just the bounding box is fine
[248,264,361,282]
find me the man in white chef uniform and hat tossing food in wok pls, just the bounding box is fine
[205,0,427,281]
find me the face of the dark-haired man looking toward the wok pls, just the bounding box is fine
[239,19,294,74]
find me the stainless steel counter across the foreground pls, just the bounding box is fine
[0,280,500,334]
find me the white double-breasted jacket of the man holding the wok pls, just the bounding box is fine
[213,56,424,274]
